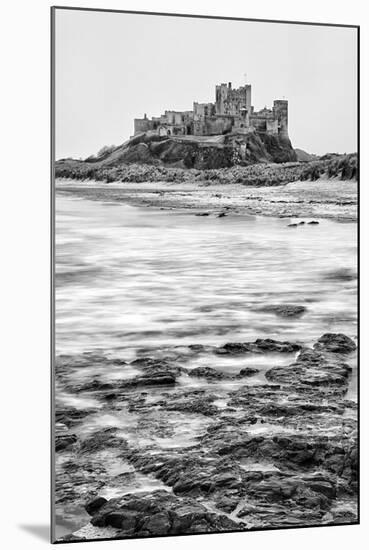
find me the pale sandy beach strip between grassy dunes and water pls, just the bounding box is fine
[56,179,357,222]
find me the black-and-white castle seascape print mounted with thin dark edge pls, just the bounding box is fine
[52,8,359,542]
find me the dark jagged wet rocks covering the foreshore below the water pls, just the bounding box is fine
[55,332,358,540]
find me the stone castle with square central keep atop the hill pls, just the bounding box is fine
[134,82,288,139]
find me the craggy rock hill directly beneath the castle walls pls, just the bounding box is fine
[80,132,296,170]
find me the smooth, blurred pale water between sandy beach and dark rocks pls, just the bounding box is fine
[56,196,356,359]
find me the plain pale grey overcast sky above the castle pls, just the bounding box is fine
[56,9,357,159]
